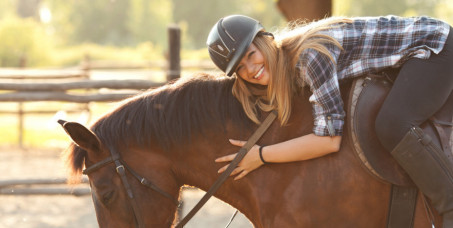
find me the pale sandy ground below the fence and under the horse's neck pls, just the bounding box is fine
[0,148,253,228]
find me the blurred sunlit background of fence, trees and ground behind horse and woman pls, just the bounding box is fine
[0,0,453,227]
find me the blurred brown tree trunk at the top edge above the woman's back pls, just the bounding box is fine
[277,0,332,21]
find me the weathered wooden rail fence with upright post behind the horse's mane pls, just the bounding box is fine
[0,26,215,150]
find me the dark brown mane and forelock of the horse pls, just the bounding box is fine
[64,73,254,176]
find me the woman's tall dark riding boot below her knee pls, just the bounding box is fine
[392,127,453,228]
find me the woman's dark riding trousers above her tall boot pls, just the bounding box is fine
[376,27,453,151]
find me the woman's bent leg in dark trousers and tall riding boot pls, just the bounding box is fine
[376,29,453,228]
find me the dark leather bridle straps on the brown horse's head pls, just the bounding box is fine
[82,146,180,228]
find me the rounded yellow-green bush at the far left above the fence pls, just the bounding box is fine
[0,17,52,67]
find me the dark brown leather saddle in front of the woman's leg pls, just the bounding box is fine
[347,75,414,186]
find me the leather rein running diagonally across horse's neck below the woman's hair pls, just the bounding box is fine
[176,111,277,228]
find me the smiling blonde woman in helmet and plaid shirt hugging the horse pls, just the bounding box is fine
[207,15,453,227]
